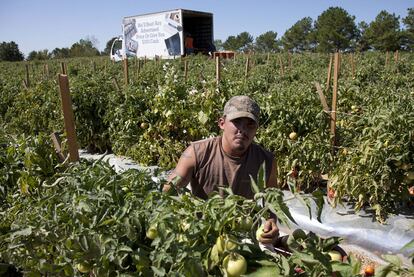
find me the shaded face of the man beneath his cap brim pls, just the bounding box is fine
[219,117,258,156]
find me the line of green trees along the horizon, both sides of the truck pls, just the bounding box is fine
[0,7,414,61]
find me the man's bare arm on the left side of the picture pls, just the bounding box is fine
[162,145,196,191]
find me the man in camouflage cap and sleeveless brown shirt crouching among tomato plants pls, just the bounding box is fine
[163,96,279,244]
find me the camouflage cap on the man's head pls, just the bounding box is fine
[223,95,260,124]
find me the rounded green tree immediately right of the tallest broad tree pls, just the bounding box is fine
[364,11,401,51]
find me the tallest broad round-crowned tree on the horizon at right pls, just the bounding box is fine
[315,7,357,52]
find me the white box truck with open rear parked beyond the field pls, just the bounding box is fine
[110,9,215,61]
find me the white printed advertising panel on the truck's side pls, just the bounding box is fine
[122,10,184,57]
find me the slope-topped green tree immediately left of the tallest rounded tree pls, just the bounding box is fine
[281,17,313,52]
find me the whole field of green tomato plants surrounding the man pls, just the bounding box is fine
[0,53,414,276]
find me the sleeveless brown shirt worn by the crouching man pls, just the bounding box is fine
[191,137,274,199]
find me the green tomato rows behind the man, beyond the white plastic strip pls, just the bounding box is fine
[0,53,414,220]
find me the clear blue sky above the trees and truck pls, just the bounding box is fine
[0,0,414,55]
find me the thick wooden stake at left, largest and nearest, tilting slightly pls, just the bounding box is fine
[58,74,79,162]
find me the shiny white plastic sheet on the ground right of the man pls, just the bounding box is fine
[285,192,414,256]
